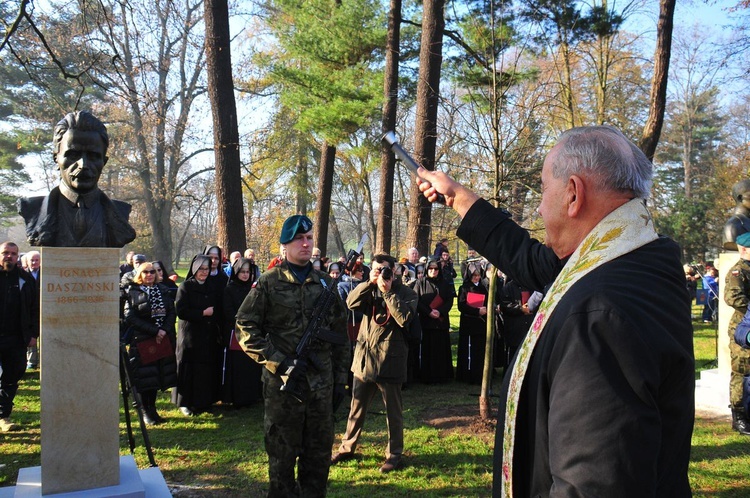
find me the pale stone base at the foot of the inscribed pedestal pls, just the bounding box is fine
[0,455,172,498]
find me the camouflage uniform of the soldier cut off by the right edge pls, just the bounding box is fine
[724,259,750,409]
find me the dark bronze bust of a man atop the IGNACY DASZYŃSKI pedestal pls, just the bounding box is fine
[18,111,135,247]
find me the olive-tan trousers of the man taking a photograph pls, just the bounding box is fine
[339,375,404,459]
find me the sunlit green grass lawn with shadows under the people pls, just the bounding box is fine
[0,304,750,498]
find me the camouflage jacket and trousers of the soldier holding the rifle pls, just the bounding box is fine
[237,261,351,498]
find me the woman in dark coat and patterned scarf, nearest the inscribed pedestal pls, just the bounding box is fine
[125,263,177,425]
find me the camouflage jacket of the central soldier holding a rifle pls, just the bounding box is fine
[236,261,351,391]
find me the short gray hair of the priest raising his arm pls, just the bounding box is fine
[552,125,654,199]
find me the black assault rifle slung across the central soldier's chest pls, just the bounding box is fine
[281,234,367,403]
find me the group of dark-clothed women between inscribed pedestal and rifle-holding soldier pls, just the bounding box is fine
[120,246,262,425]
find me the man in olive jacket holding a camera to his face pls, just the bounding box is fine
[331,254,417,473]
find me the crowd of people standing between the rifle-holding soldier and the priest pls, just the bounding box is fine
[268,239,544,388]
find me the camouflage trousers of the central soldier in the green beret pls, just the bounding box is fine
[263,370,334,498]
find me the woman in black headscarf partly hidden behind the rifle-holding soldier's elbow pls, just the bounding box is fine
[221,258,263,408]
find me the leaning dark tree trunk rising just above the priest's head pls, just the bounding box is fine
[639,0,675,161]
